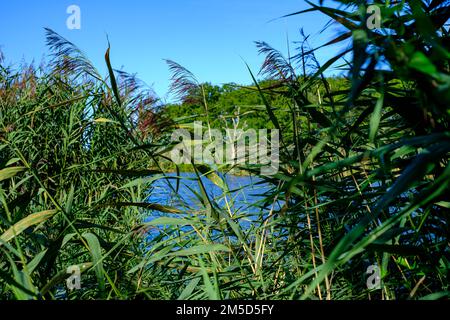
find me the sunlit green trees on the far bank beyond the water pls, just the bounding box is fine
[164,77,348,132]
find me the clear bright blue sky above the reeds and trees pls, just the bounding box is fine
[0,0,344,99]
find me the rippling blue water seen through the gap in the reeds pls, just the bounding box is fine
[146,173,283,240]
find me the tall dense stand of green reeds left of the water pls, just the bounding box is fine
[0,30,172,299]
